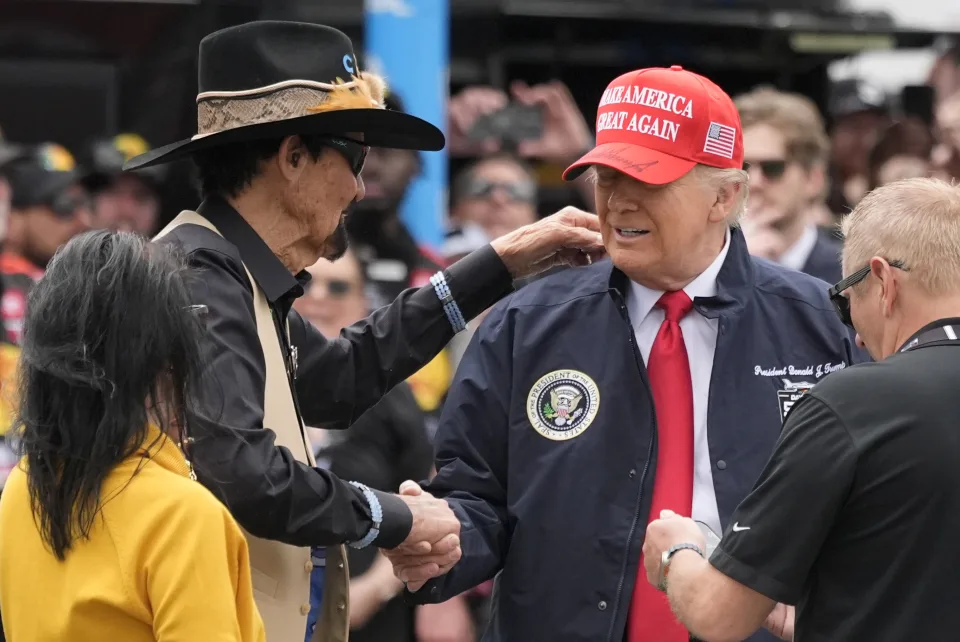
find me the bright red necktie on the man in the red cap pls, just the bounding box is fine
[627,290,693,642]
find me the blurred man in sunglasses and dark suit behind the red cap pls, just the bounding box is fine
[736,88,842,283]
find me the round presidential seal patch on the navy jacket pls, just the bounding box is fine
[527,370,600,441]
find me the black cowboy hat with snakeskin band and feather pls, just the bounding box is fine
[123,20,444,170]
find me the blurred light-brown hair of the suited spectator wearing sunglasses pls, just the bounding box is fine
[734,87,830,167]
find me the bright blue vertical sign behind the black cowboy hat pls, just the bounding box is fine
[363,0,450,248]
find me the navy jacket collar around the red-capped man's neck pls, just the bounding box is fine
[606,227,754,318]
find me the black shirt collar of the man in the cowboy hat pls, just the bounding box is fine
[197,196,310,303]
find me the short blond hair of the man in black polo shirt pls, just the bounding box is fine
[842,178,960,296]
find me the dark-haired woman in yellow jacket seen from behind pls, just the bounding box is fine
[0,231,265,642]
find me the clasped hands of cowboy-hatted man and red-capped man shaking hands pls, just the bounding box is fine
[383,481,461,591]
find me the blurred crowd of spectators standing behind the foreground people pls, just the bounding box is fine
[0,42,960,642]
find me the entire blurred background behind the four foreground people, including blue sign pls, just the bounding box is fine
[0,0,960,642]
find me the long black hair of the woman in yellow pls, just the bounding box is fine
[17,231,202,560]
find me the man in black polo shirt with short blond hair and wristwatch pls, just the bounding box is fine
[644,179,960,642]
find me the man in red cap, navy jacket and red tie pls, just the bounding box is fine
[387,67,863,642]
